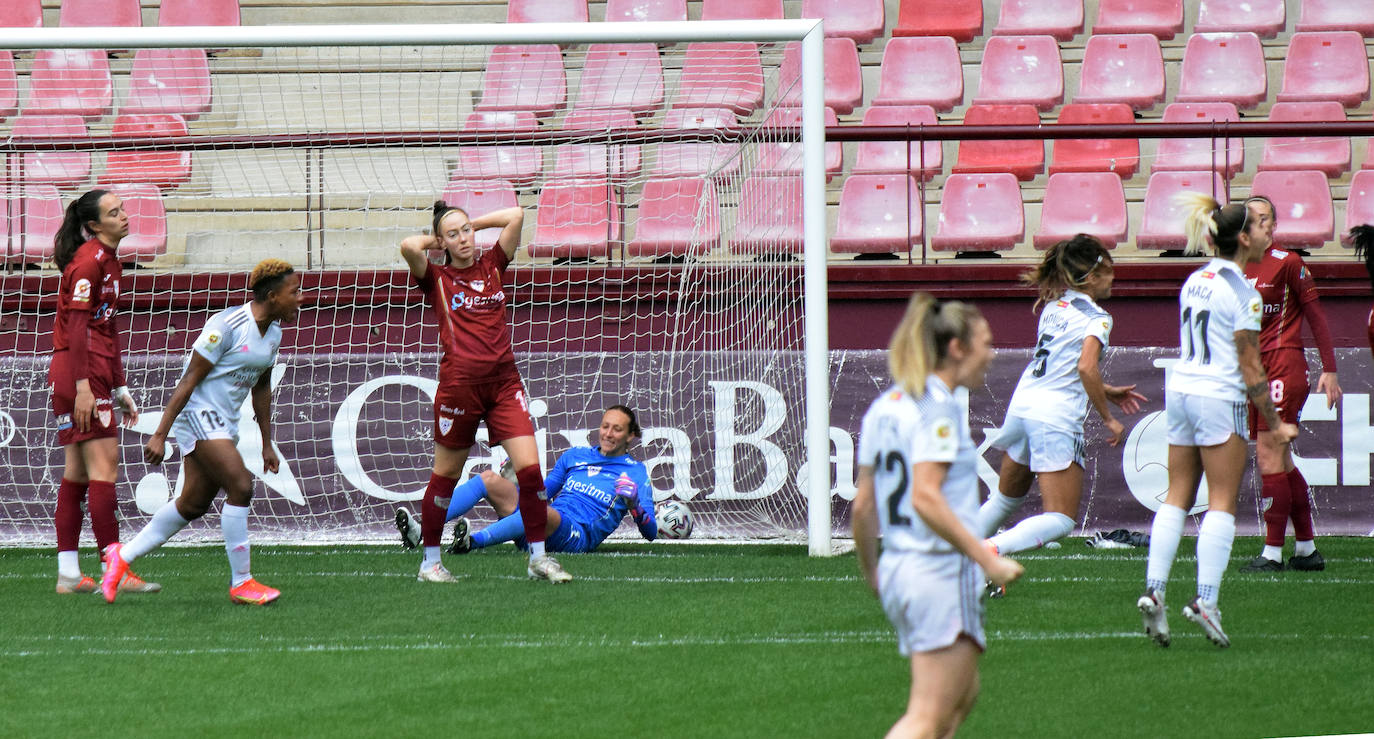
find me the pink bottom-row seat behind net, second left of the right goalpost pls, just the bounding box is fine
[625,177,720,257]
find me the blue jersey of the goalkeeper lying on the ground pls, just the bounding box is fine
[544,446,658,548]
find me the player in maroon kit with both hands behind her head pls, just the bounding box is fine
[396,201,572,584]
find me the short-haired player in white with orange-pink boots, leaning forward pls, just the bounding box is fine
[100,260,301,606]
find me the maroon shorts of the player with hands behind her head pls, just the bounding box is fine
[434,374,534,449]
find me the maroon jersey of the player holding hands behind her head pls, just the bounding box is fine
[415,246,515,383]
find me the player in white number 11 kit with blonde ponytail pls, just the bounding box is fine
[1136,192,1297,647]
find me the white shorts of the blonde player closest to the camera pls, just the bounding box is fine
[878,551,988,657]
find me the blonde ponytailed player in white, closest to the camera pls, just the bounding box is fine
[852,293,1022,736]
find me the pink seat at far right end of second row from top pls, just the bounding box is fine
[1279,30,1370,107]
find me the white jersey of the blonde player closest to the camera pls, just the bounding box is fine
[859,375,978,552]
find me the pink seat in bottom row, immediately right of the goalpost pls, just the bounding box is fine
[830,174,922,254]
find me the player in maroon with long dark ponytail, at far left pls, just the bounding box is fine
[48,190,161,593]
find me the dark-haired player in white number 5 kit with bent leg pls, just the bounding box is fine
[978,234,1146,565]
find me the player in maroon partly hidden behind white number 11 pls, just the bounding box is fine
[1241,196,1341,573]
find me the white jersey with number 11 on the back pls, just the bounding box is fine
[1165,260,1264,401]
